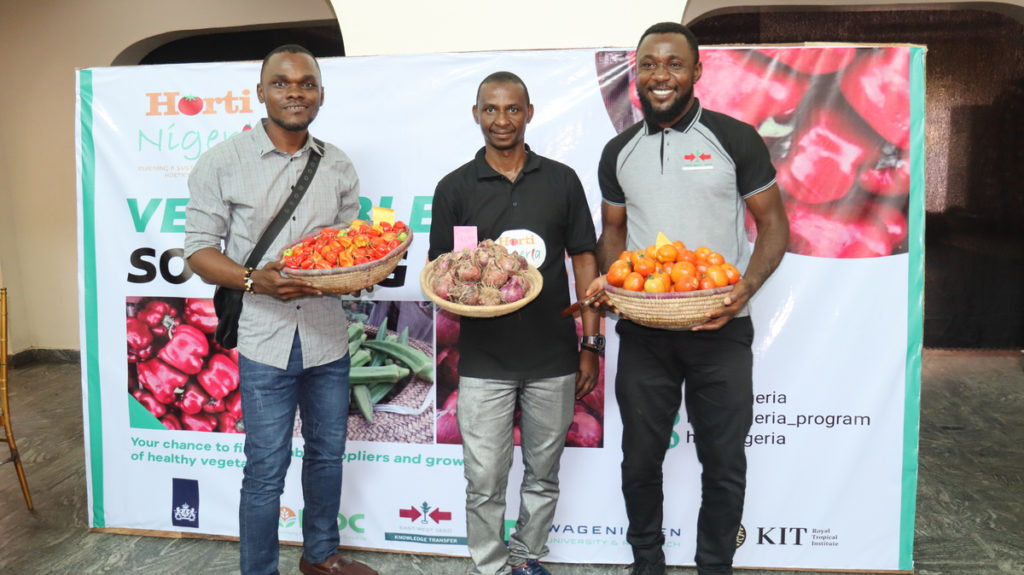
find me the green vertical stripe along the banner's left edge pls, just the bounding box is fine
[78,70,106,527]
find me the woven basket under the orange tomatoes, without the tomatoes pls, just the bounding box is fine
[604,281,732,329]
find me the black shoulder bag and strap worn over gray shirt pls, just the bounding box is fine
[213,138,324,349]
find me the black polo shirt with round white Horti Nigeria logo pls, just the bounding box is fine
[429,146,597,380]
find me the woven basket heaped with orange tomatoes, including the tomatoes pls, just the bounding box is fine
[604,236,740,329]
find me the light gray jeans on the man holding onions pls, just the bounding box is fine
[456,373,575,575]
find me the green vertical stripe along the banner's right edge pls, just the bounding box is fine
[899,46,925,571]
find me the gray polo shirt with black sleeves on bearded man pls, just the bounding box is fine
[598,99,775,282]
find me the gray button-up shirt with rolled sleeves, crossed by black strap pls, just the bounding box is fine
[184,124,359,369]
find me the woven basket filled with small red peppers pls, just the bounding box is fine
[282,220,413,294]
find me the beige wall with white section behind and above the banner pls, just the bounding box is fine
[0,0,1024,353]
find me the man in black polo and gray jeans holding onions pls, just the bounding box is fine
[429,72,603,575]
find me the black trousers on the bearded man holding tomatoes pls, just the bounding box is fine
[615,317,754,575]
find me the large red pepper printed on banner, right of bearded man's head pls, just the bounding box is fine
[693,50,808,128]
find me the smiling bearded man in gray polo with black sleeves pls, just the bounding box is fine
[588,23,788,575]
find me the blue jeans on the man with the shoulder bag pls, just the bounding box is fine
[239,333,349,575]
